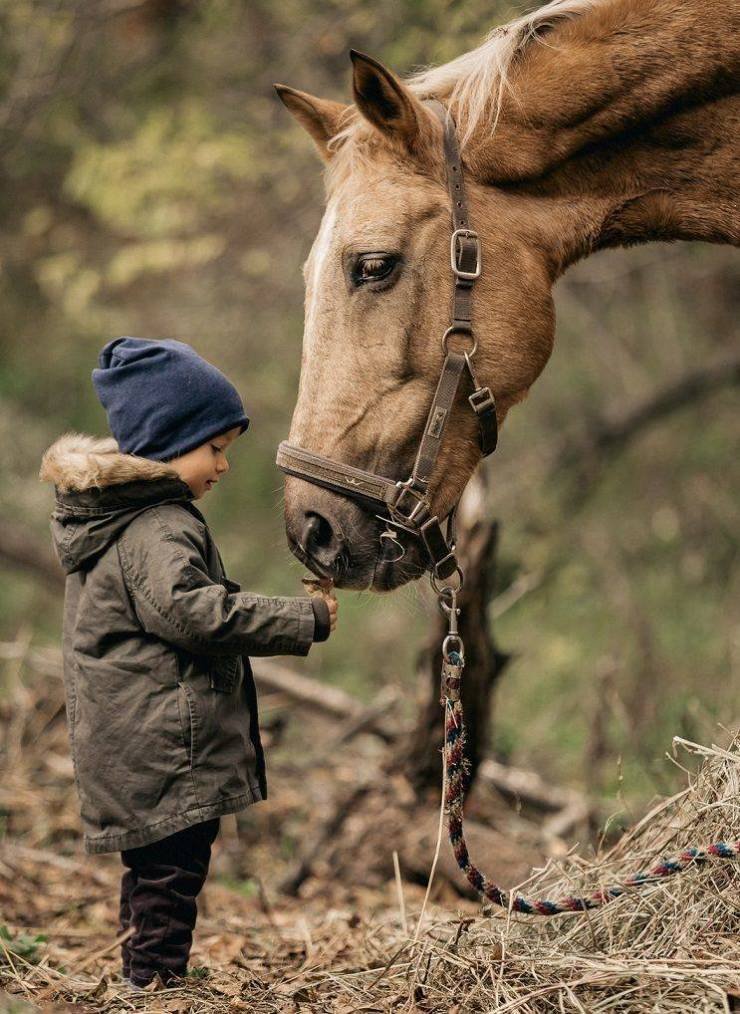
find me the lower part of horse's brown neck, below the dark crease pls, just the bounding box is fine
[506,96,740,279]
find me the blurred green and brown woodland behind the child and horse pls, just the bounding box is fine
[0,0,740,823]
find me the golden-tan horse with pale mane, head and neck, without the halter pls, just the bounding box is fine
[277,0,740,590]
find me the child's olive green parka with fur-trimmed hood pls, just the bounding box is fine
[41,434,316,853]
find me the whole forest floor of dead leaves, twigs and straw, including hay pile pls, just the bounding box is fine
[0,653,740,1014]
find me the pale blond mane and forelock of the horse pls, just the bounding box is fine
[329,0,604,158]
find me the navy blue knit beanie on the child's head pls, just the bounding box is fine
[92,338,249,461]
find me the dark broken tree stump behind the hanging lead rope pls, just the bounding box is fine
[398,474,508,795]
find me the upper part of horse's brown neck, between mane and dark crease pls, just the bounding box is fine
[460,0,740,184]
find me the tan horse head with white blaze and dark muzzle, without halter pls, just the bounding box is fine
[278,54,554,590]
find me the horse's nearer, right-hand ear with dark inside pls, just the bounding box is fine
[350,50,428,151]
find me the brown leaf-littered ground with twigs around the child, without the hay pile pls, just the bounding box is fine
[0,659,541,1012]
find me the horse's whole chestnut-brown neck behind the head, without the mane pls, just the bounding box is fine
[465,0,740,269]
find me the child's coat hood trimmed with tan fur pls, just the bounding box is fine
[39,433,193,574]
